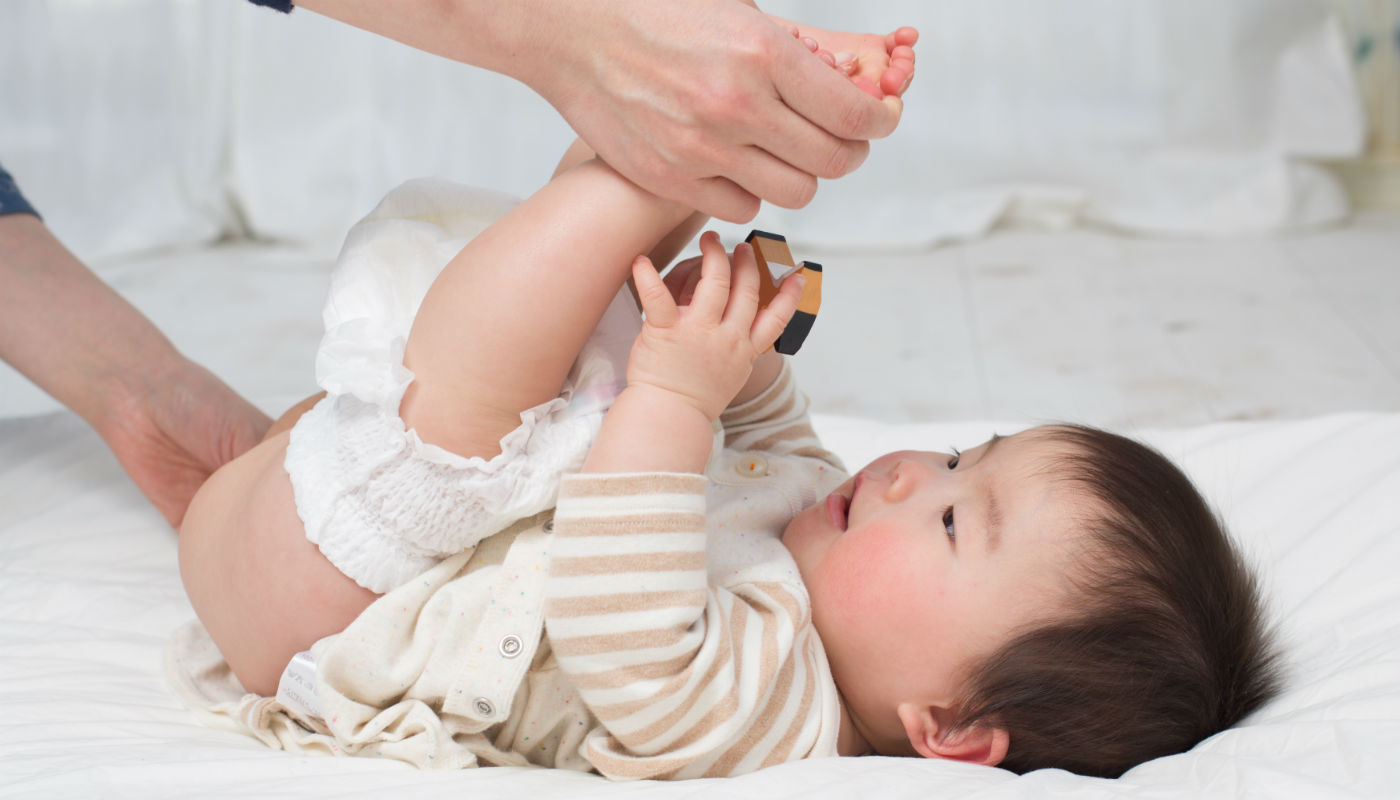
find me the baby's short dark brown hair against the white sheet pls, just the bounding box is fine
[955,425,1280,778]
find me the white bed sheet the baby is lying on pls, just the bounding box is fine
[0,412,1400,800]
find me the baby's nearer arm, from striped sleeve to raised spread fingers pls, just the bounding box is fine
[545,242,826,778]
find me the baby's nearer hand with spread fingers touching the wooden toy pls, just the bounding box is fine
[627,231,802,420]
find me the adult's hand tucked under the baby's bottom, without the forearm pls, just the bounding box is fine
[98,359,270,528]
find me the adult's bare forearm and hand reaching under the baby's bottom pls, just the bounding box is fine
[0,213,269,525]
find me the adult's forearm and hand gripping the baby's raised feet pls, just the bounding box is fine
[289,0,914,221]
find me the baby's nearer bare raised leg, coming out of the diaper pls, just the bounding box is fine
[399,160,690,458]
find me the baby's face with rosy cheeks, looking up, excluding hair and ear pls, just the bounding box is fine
[783,430,1077,722]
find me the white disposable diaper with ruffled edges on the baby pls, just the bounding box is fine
[284,181,640,593]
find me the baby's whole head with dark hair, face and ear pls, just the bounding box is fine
[783,426,1277,776]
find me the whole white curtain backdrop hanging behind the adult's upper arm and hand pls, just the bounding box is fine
[0,0,1365,258]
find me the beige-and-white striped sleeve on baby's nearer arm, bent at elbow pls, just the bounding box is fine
[545,475,819,778]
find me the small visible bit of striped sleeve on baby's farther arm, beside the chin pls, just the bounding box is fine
[720,359,846,471]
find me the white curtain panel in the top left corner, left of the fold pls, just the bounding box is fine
[0,0,232,258]
